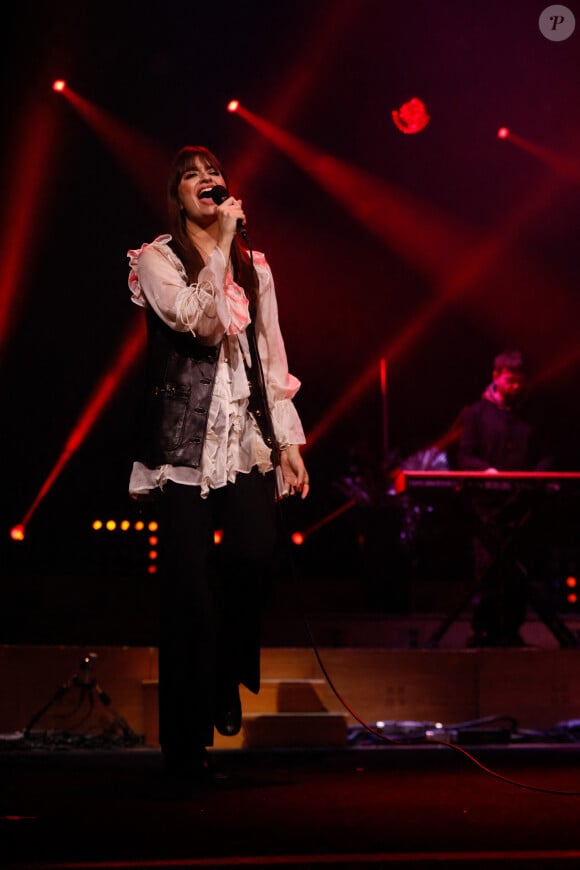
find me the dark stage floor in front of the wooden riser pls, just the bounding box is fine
[0,744,580,870]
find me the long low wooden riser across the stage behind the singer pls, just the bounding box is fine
[0,646,580,749]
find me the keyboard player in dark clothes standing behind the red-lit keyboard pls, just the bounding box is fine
[457,350,552,647]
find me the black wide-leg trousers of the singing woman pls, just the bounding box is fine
[159,469,277,753]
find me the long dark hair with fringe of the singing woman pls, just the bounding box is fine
[167,145,258,312]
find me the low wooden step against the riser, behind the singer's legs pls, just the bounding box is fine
[143,677,348,749]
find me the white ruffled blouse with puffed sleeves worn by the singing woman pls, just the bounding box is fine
[127,235,306,498]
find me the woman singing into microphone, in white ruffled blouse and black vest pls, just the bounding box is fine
[128,146,309,784]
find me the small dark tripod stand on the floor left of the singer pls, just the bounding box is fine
[24,652,139,744]
